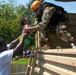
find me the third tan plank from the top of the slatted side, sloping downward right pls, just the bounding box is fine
[37,62,76,75]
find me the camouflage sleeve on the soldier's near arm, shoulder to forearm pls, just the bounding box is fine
[36,7,56,30]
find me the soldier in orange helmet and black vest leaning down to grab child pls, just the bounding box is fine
[26,1,74,48]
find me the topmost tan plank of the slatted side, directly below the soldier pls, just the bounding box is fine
[38,49,76,55]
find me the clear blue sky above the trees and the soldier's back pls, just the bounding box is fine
[0,0,76,13]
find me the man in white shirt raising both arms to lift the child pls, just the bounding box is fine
[0,33,28,75]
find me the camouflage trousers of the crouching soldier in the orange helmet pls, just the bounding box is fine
[41,22,74,48]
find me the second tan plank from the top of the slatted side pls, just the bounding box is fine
[38,54,76,67]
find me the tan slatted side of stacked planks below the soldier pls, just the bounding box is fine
[35,49,76,75]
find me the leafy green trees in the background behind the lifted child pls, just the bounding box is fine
[0,0,35,43]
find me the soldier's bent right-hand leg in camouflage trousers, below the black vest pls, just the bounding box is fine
[56,22,74,42]
